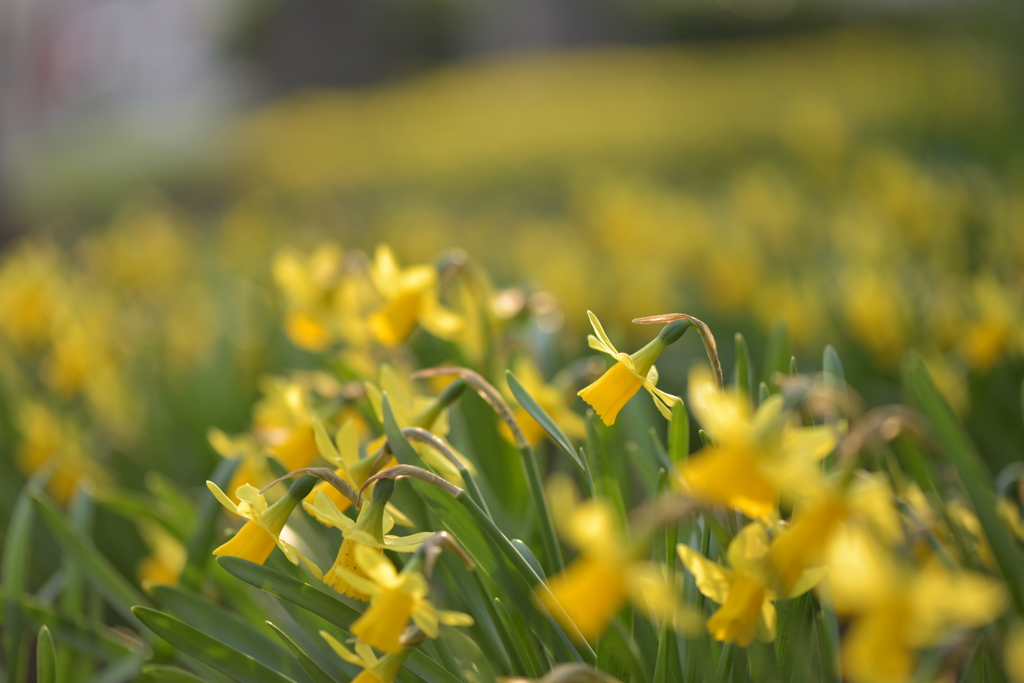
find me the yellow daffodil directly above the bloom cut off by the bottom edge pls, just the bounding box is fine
[340,545,473,653]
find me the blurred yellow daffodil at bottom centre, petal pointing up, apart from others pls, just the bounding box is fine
[537,476,689,641]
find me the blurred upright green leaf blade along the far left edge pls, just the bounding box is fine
[3,490,32,681]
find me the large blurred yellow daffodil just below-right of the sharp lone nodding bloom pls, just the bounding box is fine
[677,368,837,519]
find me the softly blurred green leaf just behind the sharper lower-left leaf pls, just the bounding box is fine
[150,586,305,680]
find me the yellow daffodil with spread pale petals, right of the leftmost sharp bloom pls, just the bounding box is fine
[303,479,432,601]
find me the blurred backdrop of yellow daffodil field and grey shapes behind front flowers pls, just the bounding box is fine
[0,0,1024,589]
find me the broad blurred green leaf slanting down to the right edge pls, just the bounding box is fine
[903,353,1024,615]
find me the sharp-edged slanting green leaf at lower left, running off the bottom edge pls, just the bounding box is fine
[132,607,292,683]
